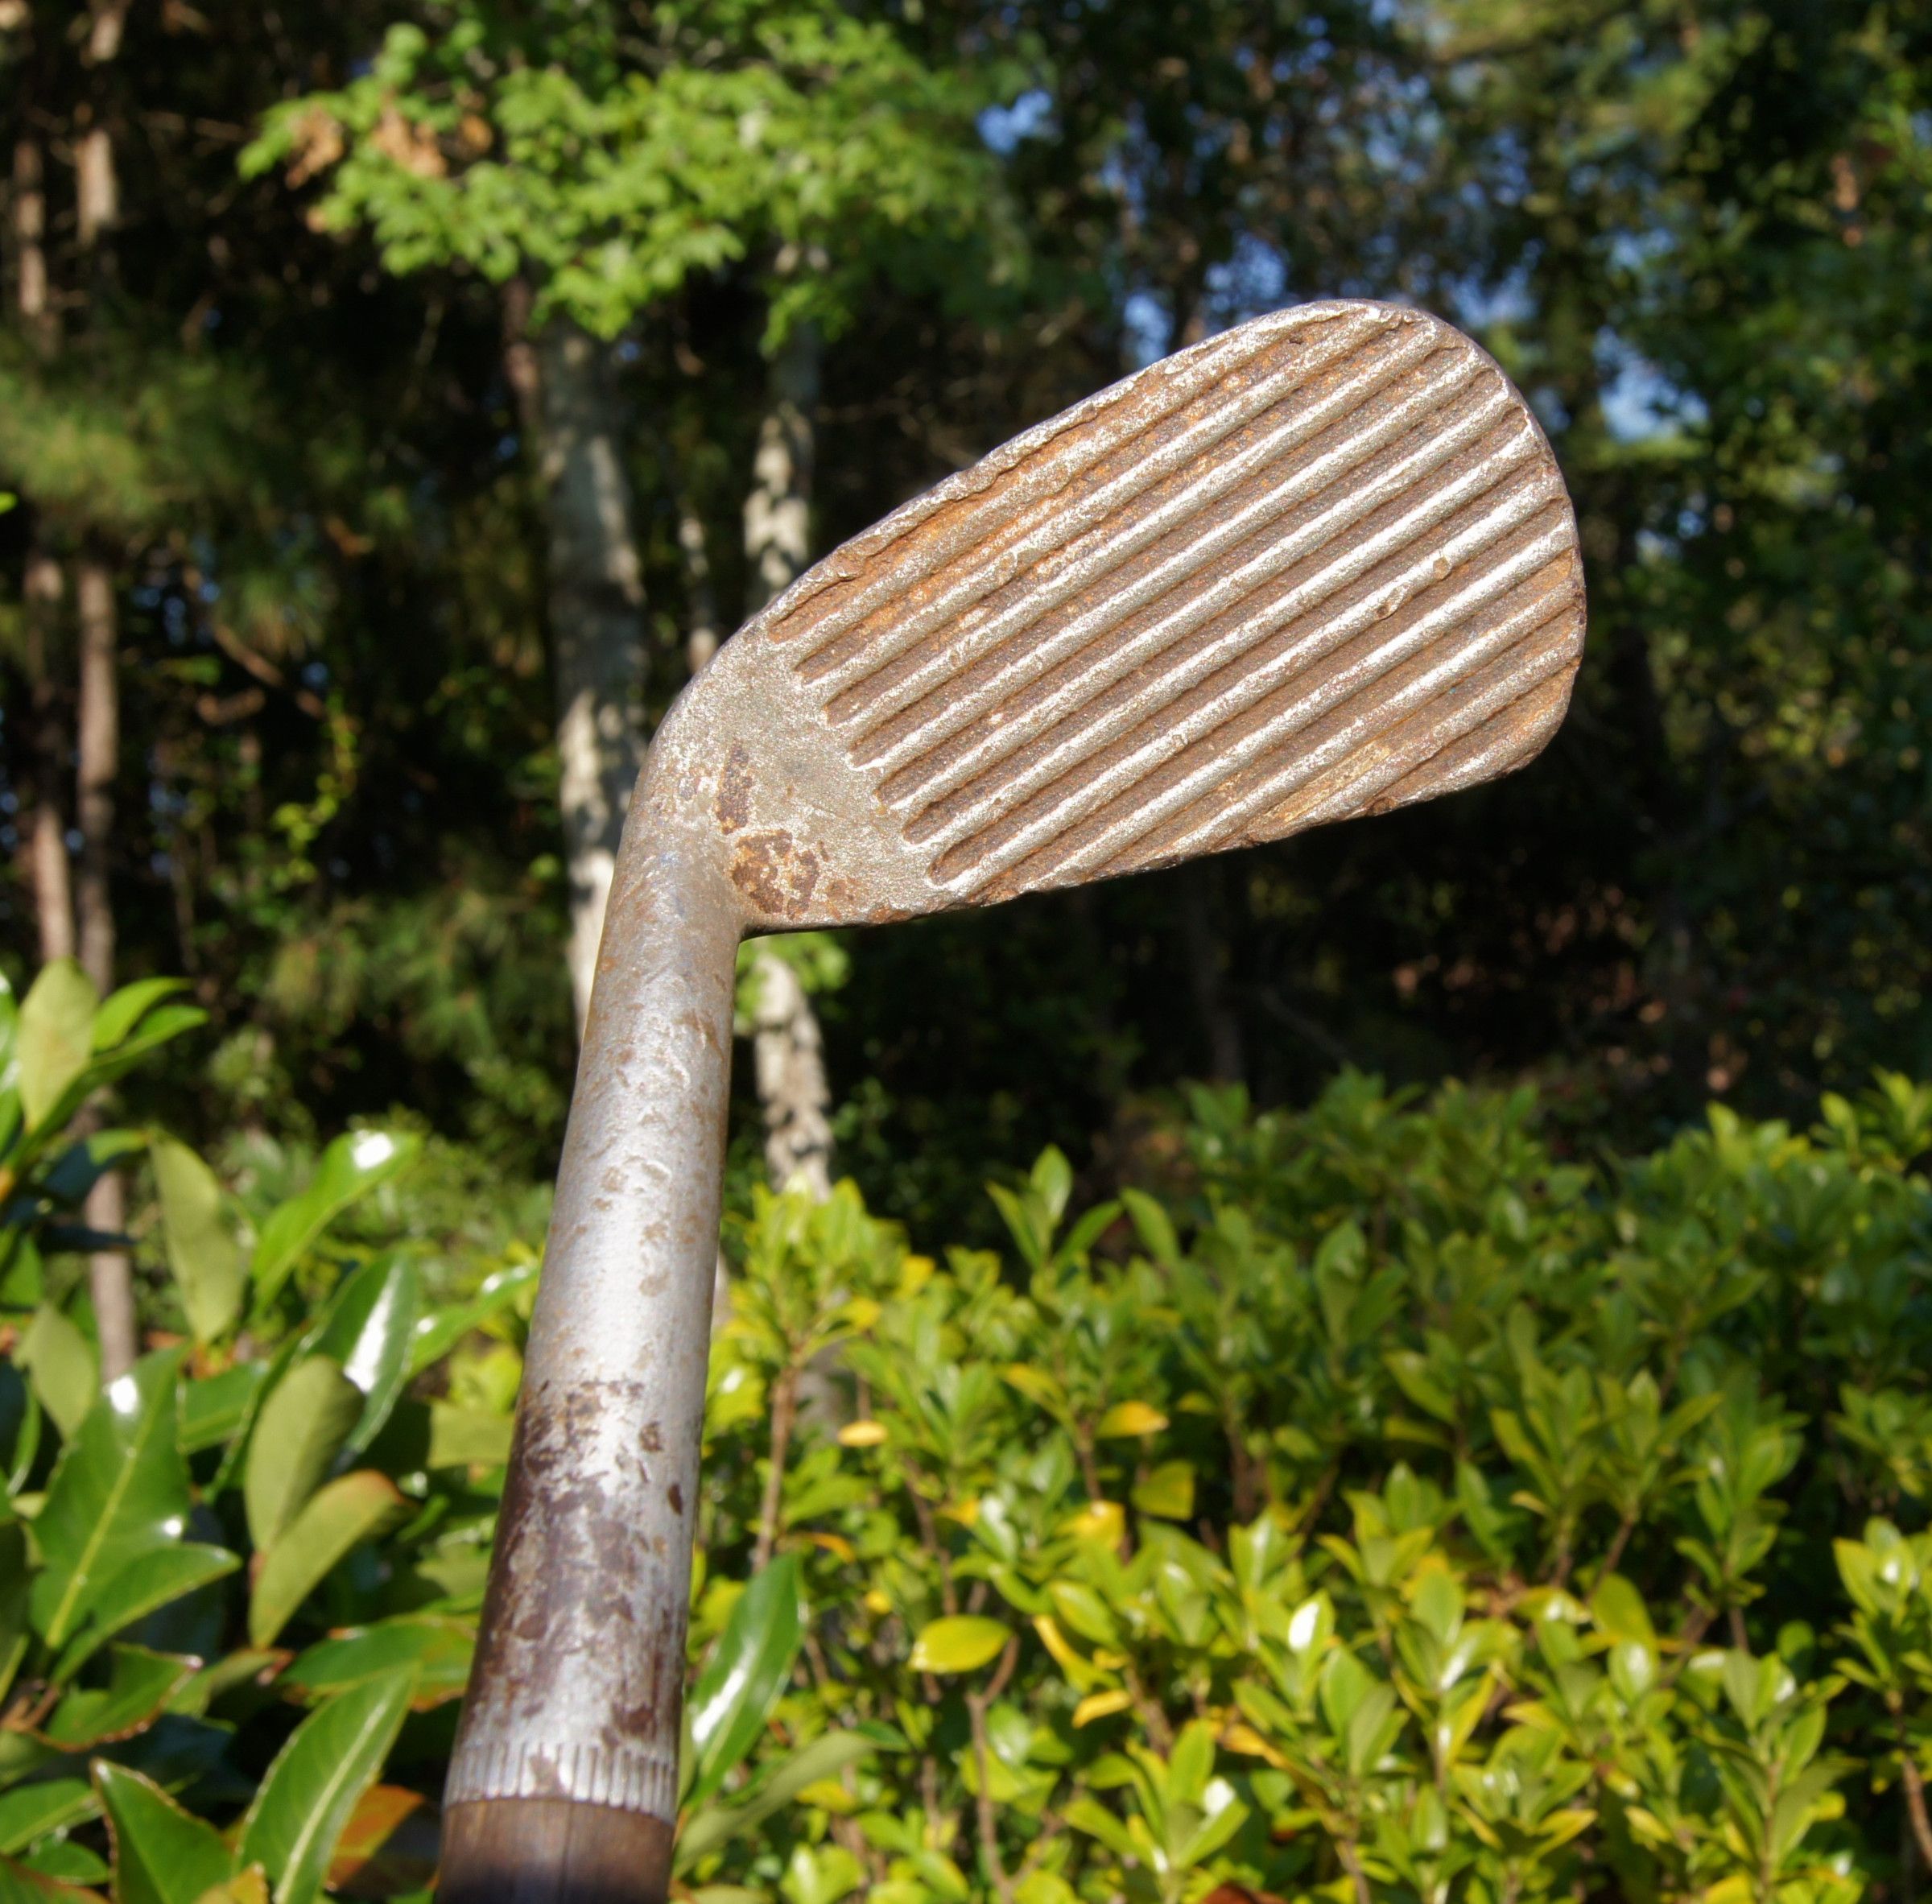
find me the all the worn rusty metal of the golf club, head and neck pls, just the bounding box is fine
[448,304,1584,1896]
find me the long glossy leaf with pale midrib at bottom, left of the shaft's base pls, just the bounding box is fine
[242,1672,415,1904]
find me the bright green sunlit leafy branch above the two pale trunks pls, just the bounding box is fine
[243,0,1027,338]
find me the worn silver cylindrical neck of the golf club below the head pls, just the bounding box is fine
[439,754,744,1904]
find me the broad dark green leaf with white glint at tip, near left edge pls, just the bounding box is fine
[31,1349,189,1647]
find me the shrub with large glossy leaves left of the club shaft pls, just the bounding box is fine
[0,967,529,1904]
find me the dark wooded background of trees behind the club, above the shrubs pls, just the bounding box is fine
[0,0,1932,1235]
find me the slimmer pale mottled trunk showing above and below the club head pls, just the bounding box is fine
[744,324,832,1202]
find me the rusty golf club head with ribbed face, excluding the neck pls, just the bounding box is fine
[657,304,1584,931]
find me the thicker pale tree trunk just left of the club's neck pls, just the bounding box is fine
[525,319,649,1035]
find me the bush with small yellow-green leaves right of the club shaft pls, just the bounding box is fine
[686,1076,1932,1904]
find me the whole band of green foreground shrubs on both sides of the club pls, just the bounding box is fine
[0,980,1932,1904]
